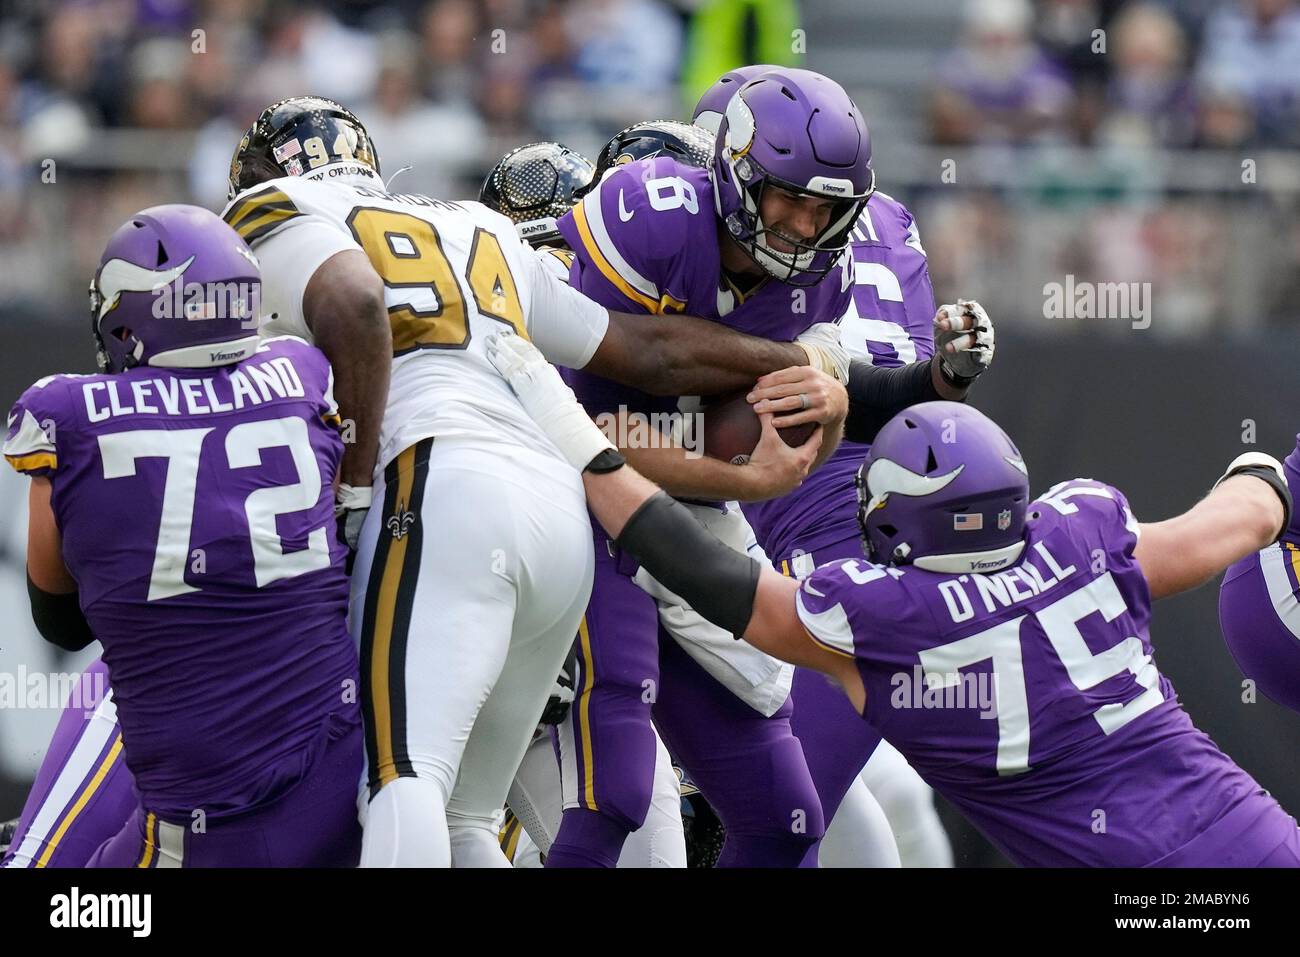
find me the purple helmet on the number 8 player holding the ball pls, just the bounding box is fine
[710,69,875,286]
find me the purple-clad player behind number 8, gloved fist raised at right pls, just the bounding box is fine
[693,65,972,866]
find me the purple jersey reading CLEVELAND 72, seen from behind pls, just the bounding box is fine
[4,338,358,819]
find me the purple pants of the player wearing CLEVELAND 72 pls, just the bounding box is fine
[87,711,364,867]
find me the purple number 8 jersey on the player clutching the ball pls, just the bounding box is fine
[559,156,853,412]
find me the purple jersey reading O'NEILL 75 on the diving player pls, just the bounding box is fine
[798,480,1295,866]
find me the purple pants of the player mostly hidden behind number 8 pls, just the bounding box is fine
[776,534,880,867]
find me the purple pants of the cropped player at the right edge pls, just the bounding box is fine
[1219,541,1300,711]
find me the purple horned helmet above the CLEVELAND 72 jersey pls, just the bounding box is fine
[90,204,261,372]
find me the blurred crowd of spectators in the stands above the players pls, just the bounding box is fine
[0,0,1300,333]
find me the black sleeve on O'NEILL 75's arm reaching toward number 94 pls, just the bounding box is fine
[618,492,763,638]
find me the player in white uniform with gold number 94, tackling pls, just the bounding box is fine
[224,98,863,866]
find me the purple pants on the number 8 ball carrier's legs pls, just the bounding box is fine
[546,520,824,867]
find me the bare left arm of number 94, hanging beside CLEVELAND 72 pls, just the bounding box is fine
[303,250,393,488]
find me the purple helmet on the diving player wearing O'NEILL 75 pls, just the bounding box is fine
[857,402,1030,573]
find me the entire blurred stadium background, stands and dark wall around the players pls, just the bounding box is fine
[0,0,1300,865]
